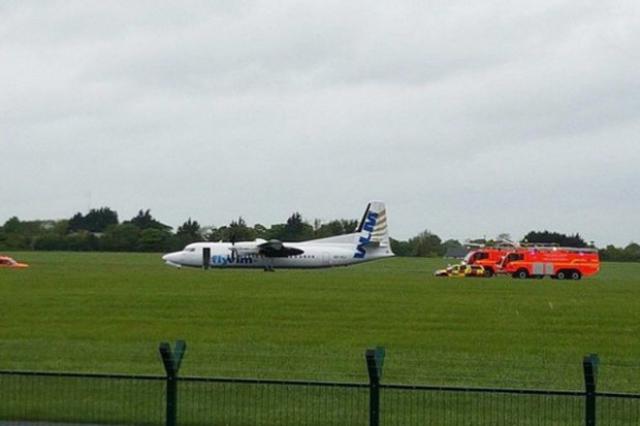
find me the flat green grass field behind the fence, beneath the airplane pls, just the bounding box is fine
[0,252,640,391]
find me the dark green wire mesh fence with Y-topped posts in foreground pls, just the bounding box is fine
[0,342,640,426]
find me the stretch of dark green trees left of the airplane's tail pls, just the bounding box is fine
[0,207,358,252]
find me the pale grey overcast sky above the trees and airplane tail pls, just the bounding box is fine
[0,0,640,245]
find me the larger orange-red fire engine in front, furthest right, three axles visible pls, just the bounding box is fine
[500,247,600,280]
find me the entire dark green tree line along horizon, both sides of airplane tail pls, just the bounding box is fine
[0,207,640,262]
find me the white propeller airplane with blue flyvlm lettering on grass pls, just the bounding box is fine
[162,201,393,271]
